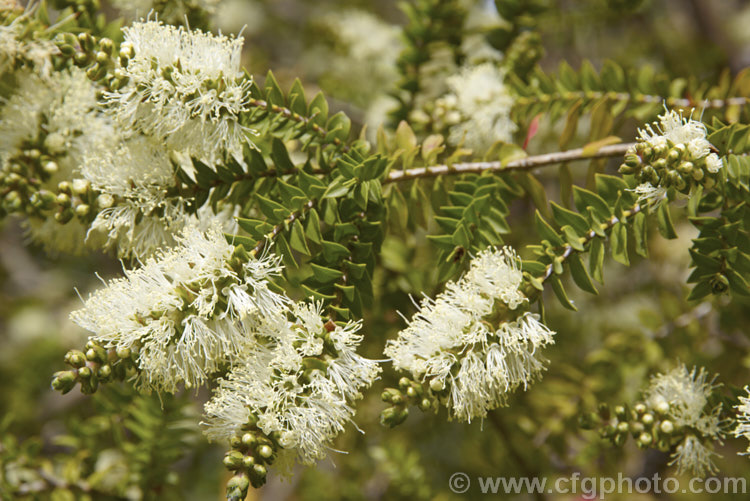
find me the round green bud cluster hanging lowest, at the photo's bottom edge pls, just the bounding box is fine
[224,414,281,494]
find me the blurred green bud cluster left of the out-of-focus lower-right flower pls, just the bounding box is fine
[579,401,683,452]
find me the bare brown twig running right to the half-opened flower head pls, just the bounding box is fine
[383,143,635,184]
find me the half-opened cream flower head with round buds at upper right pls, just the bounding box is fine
[620,110,723,204]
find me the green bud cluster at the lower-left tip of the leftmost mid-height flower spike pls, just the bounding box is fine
[52,341,137,395]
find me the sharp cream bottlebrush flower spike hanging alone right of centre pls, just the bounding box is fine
[385,247,554,421]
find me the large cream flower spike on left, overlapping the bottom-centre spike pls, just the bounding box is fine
[71,223,289,392]
